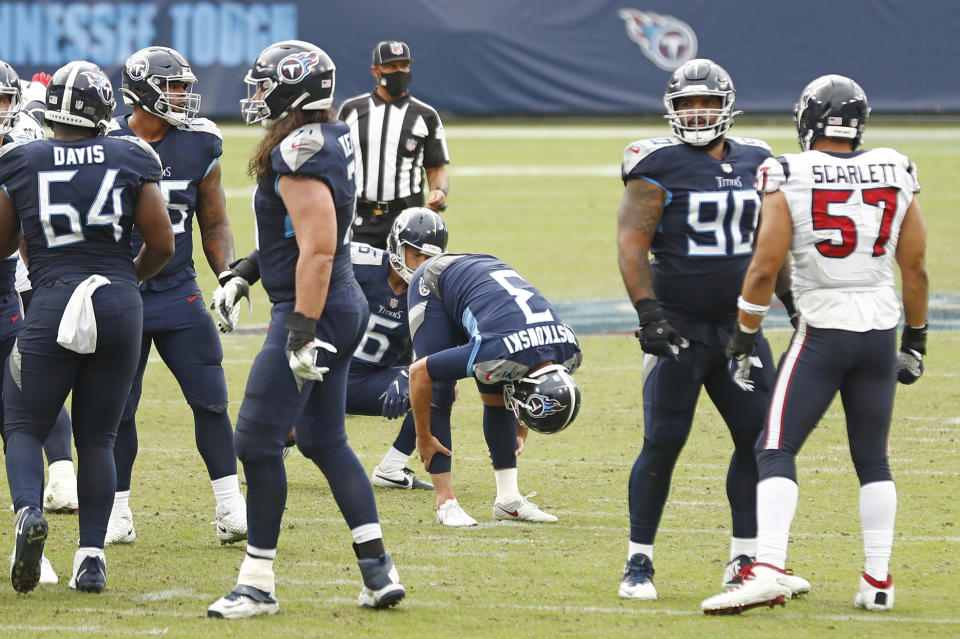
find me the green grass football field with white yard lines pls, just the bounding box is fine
[0,125,960,638]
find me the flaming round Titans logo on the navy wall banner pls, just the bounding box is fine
[618,9,697,71]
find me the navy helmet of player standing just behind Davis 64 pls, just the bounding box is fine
[120,47,200,126]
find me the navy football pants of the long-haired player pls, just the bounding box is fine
[235,296,379,549]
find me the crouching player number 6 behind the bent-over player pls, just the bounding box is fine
[347,207,447,490]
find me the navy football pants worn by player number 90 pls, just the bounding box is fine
[628,334,774,544]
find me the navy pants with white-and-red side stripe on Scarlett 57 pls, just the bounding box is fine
[757,323,897,484]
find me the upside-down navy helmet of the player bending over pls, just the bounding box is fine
[503,364,580,434]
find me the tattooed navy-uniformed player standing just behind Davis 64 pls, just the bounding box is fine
[107,47,247,543]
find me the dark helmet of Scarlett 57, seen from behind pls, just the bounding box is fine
[793,75,870,151]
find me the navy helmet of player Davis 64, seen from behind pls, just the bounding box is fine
[44,60,117,135]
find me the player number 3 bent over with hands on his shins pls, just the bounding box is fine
[407,254,582,526]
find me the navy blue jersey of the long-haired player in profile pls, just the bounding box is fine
[253,122,356,304]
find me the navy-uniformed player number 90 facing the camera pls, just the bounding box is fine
[617,59,789,600]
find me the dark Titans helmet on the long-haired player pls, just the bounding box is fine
[240,40,337,126]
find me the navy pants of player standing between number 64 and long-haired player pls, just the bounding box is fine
[114,280,237,491]
